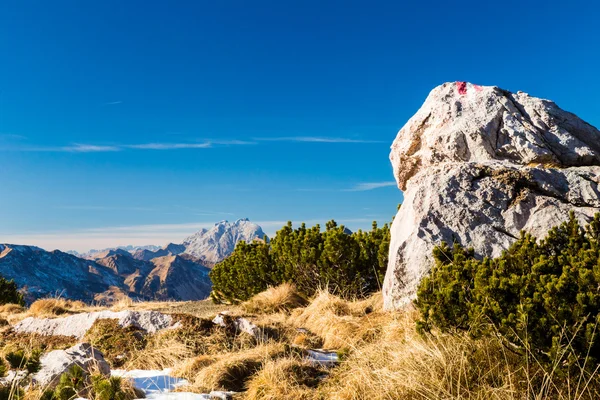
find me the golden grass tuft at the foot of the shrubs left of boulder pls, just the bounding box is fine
[242,283,308,313]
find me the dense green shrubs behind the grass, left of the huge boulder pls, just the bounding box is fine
[210,221,390,302]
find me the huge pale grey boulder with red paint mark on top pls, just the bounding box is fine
[383,82,600,309]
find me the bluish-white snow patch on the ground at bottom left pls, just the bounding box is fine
[111,369,211,400]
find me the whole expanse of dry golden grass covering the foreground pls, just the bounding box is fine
[8,288,600,400]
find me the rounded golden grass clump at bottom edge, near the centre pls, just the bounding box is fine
[244,357,326,400]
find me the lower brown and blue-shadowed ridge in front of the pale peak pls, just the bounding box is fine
[0,244,211,303]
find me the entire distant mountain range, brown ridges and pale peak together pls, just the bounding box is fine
[0,219,264,303]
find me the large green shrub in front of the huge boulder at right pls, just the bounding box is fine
[415,214,600,366]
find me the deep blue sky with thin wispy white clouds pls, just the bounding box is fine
[0,0,600,250]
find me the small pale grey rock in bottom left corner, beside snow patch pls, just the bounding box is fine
[33,343,110,388]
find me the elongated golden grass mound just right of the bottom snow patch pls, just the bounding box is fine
[189,343,286,393]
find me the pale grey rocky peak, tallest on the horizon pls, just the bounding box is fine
[183,218,265,264]
